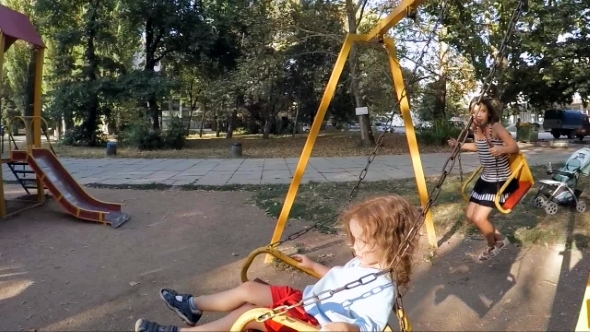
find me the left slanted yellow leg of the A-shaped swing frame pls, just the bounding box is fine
[264,34,363,263]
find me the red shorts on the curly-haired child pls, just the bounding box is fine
[264,286,319,332]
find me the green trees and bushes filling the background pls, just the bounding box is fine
[0,0,590,149]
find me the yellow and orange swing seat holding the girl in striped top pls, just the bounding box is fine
[461,153,535,214]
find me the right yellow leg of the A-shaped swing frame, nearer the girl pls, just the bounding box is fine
[383,37,438,248]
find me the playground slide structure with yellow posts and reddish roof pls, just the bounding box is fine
[0,5,129,227]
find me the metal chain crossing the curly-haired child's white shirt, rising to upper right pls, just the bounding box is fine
[256,0,527,322]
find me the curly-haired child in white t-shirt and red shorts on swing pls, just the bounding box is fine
[135,195,419,332]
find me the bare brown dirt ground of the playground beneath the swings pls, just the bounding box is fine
[0,186,590,331]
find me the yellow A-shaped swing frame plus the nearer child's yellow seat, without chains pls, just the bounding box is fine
[225,0,430,332]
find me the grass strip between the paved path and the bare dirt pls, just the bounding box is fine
[84,165,590,248]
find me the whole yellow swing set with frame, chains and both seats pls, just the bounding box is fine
[239,0,534,332]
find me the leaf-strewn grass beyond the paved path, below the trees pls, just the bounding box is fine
[32,131,450,159]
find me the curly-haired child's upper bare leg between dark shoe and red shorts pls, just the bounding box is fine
[192,281,272,312]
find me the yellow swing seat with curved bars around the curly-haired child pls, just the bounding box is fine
[236,246,412,332]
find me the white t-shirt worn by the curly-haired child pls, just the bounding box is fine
[303,257,395,332]
